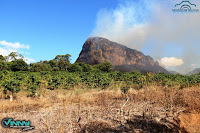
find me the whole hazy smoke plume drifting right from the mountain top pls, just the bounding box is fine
[91,0,200,73]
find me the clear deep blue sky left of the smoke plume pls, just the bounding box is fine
[0,0,118,62]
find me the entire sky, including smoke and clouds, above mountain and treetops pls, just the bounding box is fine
[0,0,200,73]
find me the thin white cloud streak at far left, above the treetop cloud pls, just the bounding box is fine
[0,40,30,49]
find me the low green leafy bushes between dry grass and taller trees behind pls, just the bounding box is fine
[0,63,200,96]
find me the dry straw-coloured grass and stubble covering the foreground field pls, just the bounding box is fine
[0,86,200,133]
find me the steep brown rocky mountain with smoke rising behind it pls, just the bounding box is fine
[76,37,169,73]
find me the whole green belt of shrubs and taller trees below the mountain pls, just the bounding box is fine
[0,52,200,96]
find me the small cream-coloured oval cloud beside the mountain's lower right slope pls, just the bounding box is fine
[158,57,184,68]
